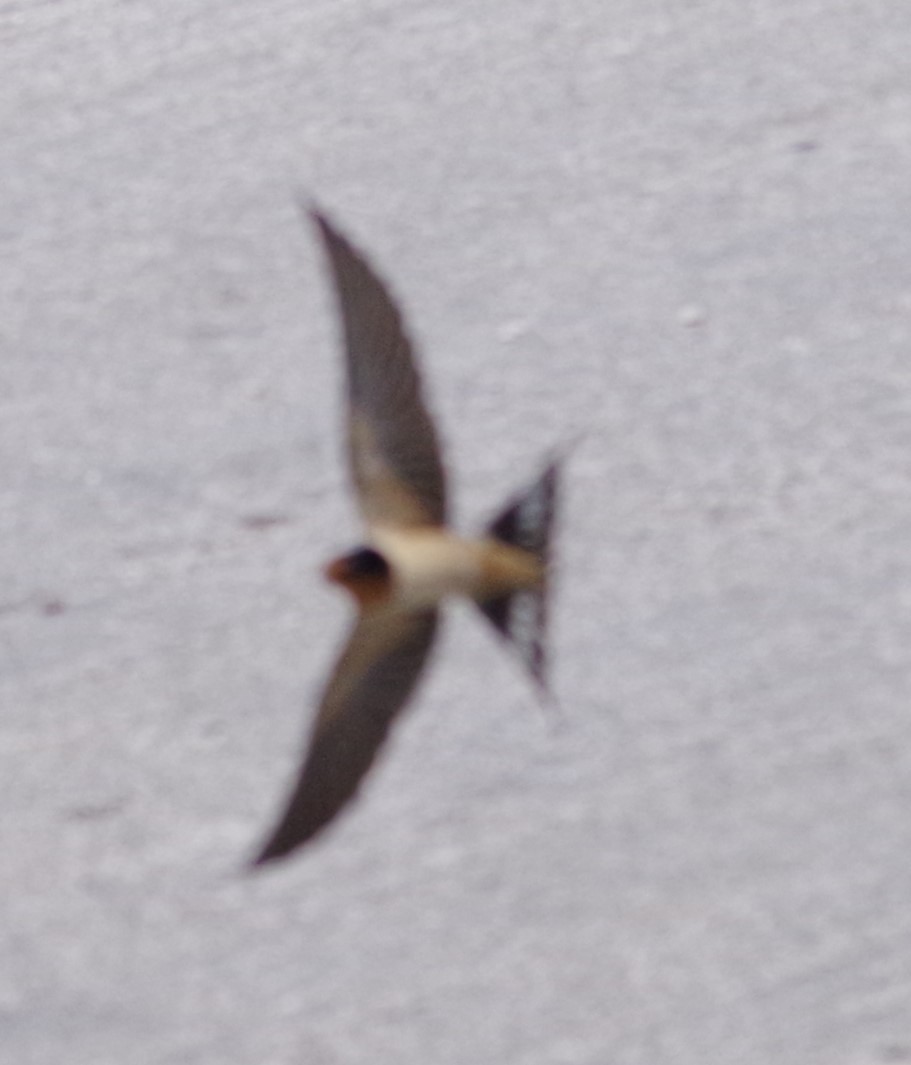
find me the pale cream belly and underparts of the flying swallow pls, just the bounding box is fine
[371,525,543,610]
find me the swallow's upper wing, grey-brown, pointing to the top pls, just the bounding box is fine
[311,211,446,526]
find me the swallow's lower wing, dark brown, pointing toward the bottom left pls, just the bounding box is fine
[253,610,438,865]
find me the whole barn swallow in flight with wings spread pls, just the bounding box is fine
[253,210,559,866]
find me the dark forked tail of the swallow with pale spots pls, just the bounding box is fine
[477,456,562,693]
